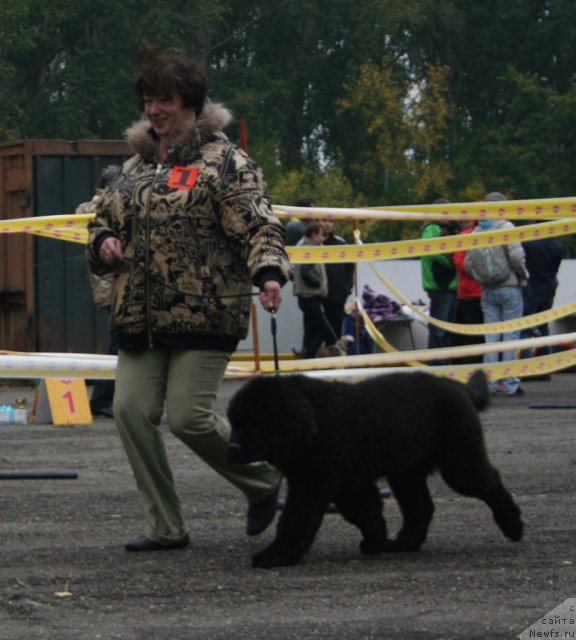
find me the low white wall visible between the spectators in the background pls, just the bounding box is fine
[238,259,576,354]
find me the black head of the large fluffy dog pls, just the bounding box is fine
[228,376,317,469]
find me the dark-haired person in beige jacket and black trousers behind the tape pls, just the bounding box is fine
[293,220,331,358]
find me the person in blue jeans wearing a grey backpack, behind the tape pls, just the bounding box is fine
[465,191,528,396]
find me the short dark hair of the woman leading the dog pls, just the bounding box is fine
[135,42,208,115]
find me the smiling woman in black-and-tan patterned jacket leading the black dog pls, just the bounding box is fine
[87,45,290,552]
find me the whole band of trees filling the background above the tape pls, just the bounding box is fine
[0,0,576,249]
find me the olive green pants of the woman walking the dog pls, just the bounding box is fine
[114,349,280,542]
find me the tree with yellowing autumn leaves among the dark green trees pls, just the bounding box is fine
[340,59,451,204]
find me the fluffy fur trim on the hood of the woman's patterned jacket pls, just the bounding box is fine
[125,100,232,162]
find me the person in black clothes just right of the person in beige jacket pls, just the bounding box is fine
[319,218,354,346]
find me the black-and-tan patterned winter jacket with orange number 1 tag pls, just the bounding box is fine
[87,102,290,351]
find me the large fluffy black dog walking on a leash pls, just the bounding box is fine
[228,370,523,567]
